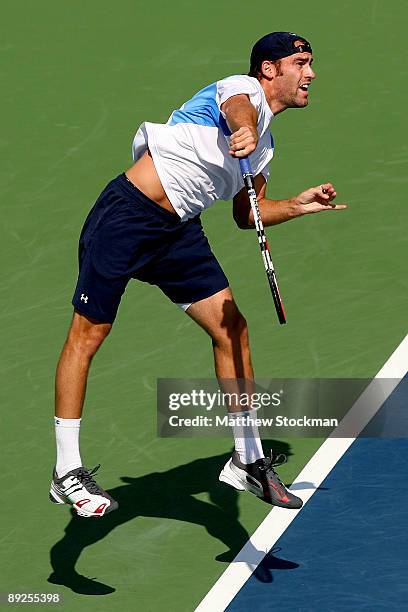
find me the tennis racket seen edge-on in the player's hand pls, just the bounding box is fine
[239,157,286,325]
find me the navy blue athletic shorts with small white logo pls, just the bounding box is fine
[72,174,228,323]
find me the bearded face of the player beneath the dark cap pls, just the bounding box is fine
[271,53,316,110]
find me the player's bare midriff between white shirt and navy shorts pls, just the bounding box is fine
[125,151,177,215]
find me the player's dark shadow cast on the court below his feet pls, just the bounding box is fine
[48,442,298,595]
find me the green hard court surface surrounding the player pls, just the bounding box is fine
[0,0,408,612]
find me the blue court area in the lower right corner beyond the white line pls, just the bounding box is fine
[227,376,408,612]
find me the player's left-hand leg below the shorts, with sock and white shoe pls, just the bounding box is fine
[50,312,118,516]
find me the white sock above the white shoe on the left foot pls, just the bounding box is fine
[54,417,82,478]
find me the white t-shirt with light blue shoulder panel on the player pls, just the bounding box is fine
[132,75,273,221]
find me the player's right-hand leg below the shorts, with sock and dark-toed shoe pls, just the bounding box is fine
[186,288,303,508]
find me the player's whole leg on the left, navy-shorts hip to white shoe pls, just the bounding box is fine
[50,174,165,516]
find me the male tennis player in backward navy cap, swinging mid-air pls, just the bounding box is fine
[50,32,345,517]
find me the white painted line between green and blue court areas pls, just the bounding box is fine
[195,335,408,612]
